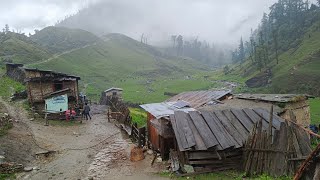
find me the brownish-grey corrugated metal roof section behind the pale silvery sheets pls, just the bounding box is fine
[166,90,231,108]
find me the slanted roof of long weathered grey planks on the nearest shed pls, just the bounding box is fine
[170,109,284,151]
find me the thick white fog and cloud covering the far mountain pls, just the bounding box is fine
[58,0,274,44]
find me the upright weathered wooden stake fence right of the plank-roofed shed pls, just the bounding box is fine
[243,120,311,177]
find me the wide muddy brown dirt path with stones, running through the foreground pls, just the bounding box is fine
[0,99,166,180]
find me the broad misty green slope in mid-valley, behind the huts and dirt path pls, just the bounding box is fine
[31,34,214,103]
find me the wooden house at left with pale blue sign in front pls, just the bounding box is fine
[7,64,80,112]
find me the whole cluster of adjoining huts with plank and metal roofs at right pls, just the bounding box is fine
[141,90,310,174]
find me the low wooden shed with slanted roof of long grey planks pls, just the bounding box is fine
[170,109,284,172]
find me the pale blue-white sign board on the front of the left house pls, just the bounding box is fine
[46,94,68,112]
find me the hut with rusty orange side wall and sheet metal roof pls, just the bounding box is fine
[141,90,231,159]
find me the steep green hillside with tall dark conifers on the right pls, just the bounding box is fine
[226,1,320,96]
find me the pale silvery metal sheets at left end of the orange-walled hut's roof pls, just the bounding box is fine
[140,102,196,119]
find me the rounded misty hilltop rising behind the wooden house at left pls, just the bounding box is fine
[30,26,100,53]
